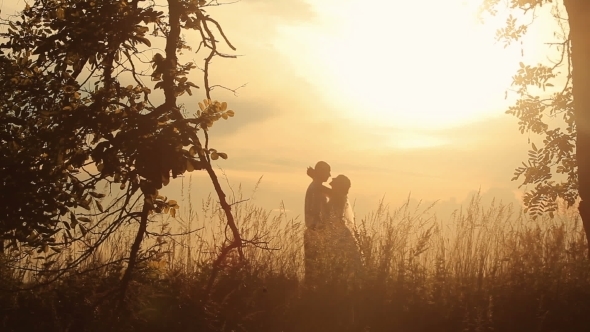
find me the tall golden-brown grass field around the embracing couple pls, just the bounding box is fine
[0,187,590,332]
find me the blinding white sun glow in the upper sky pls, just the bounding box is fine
[283,0,518,129]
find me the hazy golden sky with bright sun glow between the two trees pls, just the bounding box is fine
[2,0,568,222]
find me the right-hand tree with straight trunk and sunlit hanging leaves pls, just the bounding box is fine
[481,0,590,255]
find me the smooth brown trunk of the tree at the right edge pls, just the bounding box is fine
[564,0,590,256]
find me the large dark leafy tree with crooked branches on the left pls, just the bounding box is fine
[0,0,242,295]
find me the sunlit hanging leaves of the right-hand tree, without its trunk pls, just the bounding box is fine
[481,0,578,216]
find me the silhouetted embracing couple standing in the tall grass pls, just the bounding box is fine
[303,161,361,287]
